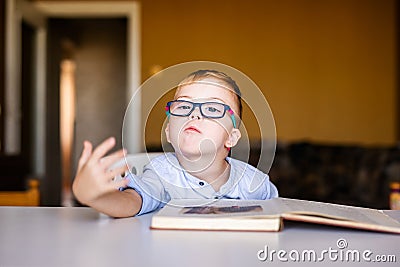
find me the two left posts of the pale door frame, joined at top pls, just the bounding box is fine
[4,0,46,176]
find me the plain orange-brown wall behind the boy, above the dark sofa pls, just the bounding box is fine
[140,0,396,145]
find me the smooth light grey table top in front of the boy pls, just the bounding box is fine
[0,207,400,267]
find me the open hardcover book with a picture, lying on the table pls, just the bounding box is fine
[151,198,400,234]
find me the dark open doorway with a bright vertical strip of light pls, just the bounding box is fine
[47,18,127,206]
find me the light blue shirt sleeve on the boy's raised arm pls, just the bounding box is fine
[126,164,170,215]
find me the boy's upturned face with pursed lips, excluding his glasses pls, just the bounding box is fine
[165,81,240,159]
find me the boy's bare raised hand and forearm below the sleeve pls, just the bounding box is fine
[72,138,142,217]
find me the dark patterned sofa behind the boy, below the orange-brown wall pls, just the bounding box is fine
[262,142,400,209]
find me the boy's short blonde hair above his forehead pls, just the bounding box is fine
[177,70,243,119]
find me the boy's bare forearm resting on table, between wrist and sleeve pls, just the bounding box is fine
[87,189,142,218]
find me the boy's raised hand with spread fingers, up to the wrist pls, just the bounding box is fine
[72,137,128,205]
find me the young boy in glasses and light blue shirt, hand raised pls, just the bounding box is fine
[72,70,278,217]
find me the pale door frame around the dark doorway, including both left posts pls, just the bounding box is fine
[5,0,143,177]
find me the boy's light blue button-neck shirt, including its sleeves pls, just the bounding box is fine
[126,153,278,215]
